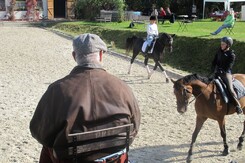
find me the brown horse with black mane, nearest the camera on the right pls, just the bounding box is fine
[171,74,245,162]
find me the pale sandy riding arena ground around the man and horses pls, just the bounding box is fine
[0,26,245,163]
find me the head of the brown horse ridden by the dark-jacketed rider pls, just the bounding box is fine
[171,79,192,114]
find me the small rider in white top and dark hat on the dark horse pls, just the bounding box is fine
[145,15,158,53]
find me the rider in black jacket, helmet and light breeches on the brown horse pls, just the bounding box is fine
[212,37,242,114]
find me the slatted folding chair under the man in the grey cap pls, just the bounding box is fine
[54,124,133,163]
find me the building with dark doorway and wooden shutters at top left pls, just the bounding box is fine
[0,0,74,20]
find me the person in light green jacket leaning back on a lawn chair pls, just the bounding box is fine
[210,11,235,35]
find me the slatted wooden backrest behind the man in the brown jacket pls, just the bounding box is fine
[54,124,133,158]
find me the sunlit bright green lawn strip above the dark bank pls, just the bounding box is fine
[56,19,245,42]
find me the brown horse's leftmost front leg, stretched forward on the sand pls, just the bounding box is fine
[186,116,207,163]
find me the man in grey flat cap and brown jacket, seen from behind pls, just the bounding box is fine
[30,33,140,163]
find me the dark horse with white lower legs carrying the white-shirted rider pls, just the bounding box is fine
[126,33,175,83]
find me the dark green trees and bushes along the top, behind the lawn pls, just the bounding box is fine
[75,0,245,21]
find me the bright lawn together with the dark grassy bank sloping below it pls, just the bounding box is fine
[50,19,245,74]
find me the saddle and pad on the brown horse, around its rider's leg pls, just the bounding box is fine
[214,77,245,103]
